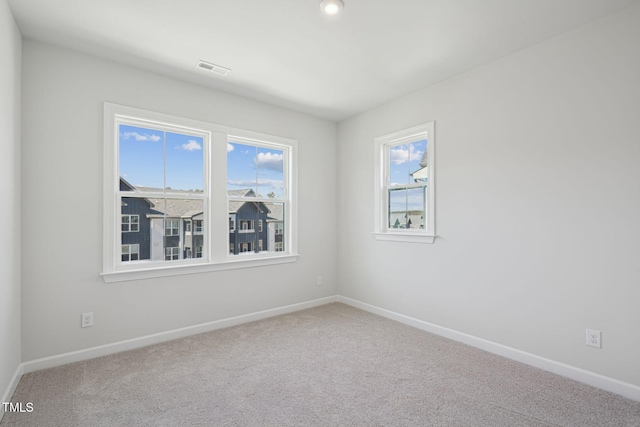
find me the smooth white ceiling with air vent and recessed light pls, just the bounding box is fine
[8,0,640,121]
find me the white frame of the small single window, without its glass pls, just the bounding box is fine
[373,122,436,243]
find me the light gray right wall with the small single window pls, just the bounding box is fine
[338,7,640,385]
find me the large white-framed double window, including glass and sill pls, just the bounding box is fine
[103,104,297,282]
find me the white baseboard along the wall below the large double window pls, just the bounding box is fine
[22,296,338,376]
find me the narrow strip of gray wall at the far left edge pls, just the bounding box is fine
[0,0,22,404]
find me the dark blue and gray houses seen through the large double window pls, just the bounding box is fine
[120,178,284,262]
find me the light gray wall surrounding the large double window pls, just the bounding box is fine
[22,41,337,361]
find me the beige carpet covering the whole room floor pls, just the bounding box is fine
[1,303,640,427]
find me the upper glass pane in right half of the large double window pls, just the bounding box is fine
[227,141,285,198]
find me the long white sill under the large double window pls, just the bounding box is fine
[101,254,299,283]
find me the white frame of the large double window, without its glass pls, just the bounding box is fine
[101,103,298,283]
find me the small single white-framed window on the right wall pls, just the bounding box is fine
[374,122,435,243]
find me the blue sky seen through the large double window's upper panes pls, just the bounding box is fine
[119,125,284,197]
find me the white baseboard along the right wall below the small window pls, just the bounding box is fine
[337,295,640,402]
